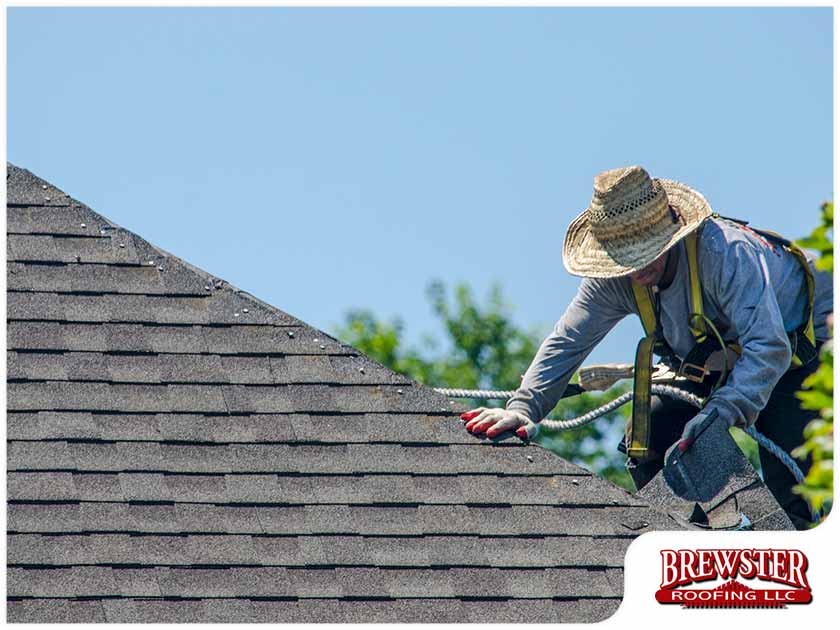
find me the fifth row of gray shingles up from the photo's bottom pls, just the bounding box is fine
[9,472,645,506]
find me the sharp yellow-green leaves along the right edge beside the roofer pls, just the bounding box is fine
[794,202,834,515]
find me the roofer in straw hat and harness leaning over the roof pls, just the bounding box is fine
[462,166,833,528]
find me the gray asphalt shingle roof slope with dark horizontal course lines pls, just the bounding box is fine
[7,165,676,622]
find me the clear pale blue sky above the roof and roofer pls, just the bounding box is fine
[7,8,833,361]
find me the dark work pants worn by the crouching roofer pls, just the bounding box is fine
[628,360,820,529]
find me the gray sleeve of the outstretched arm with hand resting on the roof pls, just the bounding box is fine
[506,278,630,422]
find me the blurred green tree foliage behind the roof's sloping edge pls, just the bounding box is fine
[335,281,632,489]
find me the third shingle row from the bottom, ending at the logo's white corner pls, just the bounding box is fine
[8,534,632,572]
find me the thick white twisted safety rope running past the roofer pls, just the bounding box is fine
[435,383,805,484]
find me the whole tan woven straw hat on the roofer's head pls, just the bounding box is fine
[563,166,712,278]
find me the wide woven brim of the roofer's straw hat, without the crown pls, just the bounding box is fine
[563,179,712,278]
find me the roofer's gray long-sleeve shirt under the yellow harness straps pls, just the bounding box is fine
[507,218,834,426]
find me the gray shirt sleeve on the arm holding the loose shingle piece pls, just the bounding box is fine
[701,241,791,427]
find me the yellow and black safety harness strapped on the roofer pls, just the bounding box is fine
[626,214,818,462]
